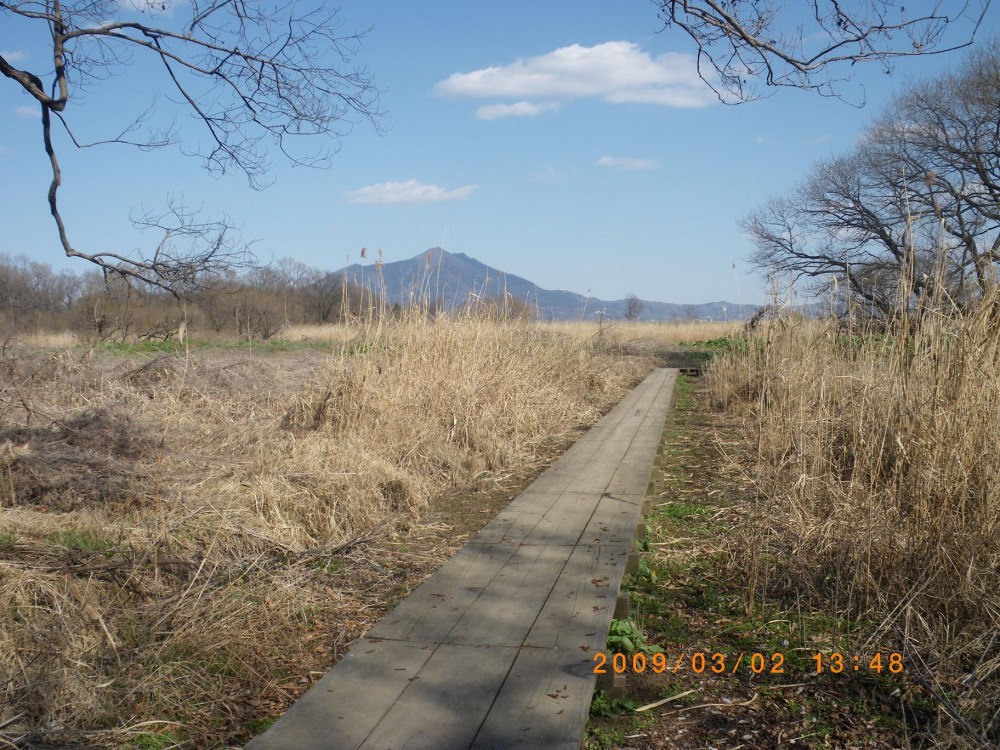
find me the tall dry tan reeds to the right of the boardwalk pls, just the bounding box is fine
[709,298,1000,746]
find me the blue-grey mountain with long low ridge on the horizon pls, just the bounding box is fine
[338,247,756,320]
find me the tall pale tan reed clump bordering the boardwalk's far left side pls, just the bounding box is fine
[282,315,636,528]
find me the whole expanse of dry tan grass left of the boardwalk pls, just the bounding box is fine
[0,317,650,747]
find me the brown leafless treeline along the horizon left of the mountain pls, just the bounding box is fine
[0,253,531,341]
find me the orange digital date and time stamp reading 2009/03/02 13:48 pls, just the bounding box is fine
[594,651,903,674]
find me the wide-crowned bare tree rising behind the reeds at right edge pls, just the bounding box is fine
[743,41,1000,315]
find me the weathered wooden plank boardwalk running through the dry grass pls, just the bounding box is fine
[247,369,677,750]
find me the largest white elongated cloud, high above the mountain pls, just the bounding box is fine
[435,42,716,114]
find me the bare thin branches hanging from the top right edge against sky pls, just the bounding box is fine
[654,0,990,102]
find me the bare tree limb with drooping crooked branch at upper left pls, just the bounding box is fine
[0,0,380,293]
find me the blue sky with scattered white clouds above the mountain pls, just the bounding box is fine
[0,0,997,303]
